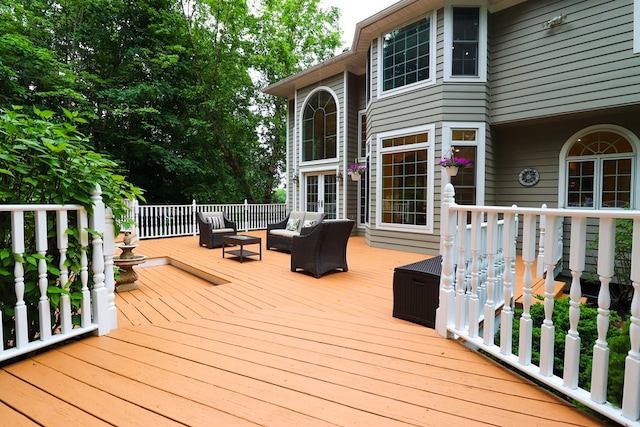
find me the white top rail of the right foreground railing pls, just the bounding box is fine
[450,204,640,219]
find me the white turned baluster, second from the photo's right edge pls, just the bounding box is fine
[591,218,616,403]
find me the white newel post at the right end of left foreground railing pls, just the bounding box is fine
[89,185,110,335]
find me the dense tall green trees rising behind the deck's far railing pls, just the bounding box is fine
[0,0,339,203]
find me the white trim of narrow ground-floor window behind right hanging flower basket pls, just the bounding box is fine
[440,122,487,205]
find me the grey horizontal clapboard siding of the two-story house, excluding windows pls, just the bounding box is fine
[288,0,640,254]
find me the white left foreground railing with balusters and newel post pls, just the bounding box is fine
[0,188,117,361]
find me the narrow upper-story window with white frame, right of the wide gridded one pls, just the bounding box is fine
[444,1,487,82]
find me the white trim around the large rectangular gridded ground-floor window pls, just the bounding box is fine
[376,124,436,234]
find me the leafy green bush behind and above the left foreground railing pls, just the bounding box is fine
[0,107,141,348]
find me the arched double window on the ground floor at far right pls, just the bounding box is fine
[563,129,637,209]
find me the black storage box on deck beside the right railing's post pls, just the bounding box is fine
[393,256,442,328]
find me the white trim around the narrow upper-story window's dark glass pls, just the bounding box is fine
[443,0,488,83]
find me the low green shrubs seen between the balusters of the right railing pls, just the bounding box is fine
[508,297,630,405]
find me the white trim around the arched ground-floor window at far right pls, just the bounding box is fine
[558,124,640,209]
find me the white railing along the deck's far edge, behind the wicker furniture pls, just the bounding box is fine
[124,200,287,239]
